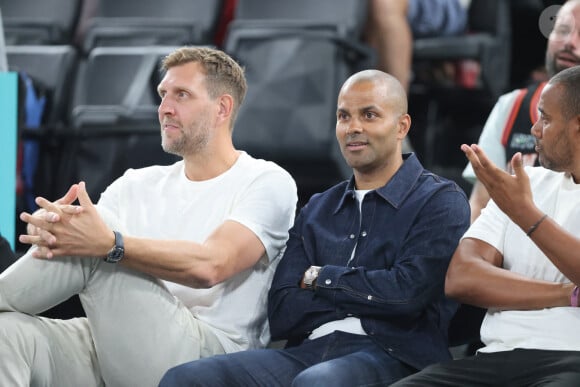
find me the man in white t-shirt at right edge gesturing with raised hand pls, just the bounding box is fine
[395,62,580,387]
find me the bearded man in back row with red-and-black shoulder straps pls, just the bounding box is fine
[462,0,580,221]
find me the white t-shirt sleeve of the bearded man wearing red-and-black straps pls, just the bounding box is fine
[461,89,520,183]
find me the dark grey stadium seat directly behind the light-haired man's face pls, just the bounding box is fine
[58,46,178,201]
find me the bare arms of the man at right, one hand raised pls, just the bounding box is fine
[454,145,580,309]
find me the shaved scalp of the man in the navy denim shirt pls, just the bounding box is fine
[339,70,407,115]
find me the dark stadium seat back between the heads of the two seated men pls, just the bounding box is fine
[224,0,373,202]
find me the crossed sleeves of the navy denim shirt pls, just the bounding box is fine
[269,188,470,338]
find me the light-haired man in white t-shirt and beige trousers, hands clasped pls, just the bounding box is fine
[0,47,297,386]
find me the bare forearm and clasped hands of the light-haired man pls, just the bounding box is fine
[20,182,265,287]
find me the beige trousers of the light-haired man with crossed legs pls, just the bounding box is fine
[0,250,224,387]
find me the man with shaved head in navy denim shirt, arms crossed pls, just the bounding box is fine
[161,70,470,387]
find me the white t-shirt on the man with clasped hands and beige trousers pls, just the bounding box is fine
[98,152,297,352]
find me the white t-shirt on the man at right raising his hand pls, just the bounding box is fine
[463,167,580,352]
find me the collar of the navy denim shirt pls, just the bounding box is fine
[334,153,424,213]
